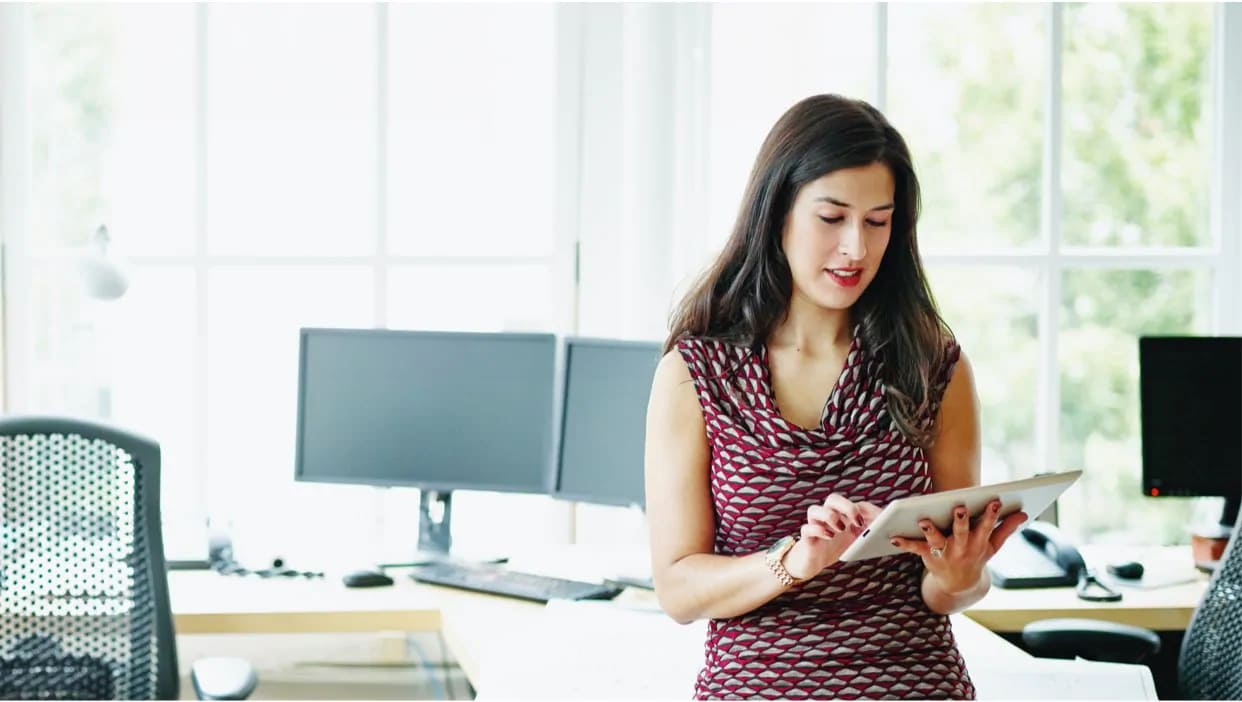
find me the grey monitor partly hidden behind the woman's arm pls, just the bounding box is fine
[553,338,661,506]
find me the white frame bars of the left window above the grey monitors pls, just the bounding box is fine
[0,2,582,546]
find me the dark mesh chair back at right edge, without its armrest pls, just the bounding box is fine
[1177,506,1242,700]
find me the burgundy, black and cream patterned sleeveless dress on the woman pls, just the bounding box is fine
[677,333,975,700]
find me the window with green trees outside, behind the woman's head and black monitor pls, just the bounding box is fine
[708,4,1227,543]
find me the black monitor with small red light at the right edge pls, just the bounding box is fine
[1139,337,1242,528]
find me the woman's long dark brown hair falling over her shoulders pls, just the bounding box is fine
[664,94,953,446]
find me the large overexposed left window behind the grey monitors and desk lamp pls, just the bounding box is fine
[9,4,569,568]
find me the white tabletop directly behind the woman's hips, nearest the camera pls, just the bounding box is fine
[472,601,1156,700]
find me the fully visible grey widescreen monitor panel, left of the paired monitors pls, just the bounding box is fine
[296,329,556,492]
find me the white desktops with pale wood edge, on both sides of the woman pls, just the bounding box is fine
[169,547,1172,700]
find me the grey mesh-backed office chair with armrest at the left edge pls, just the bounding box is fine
[0,417,256,700]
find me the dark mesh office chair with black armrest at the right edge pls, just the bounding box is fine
[1022,506,1242,700]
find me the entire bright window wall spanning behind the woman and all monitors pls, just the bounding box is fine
[0,4,1242,560]
